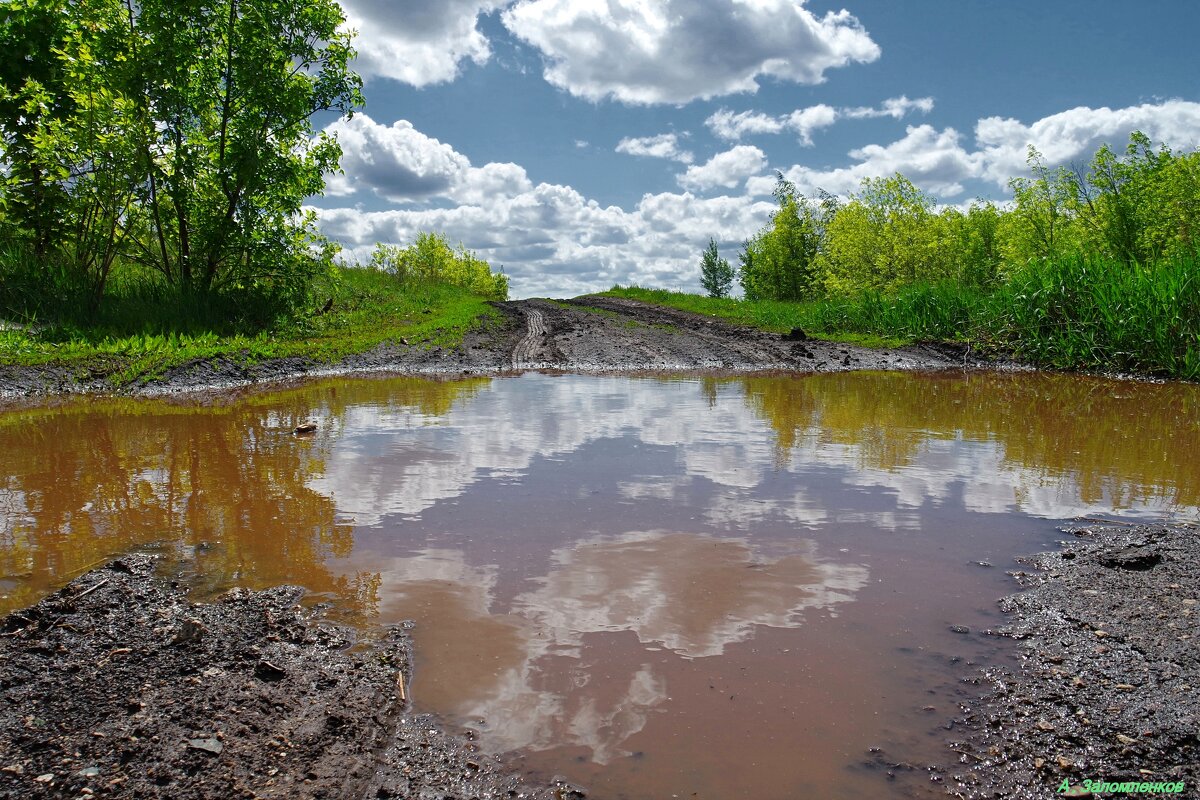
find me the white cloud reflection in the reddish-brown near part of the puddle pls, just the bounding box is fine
[350,531,868,764]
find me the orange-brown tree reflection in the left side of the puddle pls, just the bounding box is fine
[0,379,487,612]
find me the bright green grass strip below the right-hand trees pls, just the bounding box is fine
[607,255,1200,380]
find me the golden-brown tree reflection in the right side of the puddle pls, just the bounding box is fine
[734,372,1200,506]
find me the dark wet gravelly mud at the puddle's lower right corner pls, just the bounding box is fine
[947,524,1200,800]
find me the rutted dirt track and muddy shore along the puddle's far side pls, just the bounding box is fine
[0,296,976,397]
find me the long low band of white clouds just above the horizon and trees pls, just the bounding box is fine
[318,101,1200,296]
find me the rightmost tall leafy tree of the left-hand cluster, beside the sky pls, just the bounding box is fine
[125,0,362,302]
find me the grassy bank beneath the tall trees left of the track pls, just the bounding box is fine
[0,269,496,387]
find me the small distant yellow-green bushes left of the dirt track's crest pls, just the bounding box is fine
[370,233,509,300]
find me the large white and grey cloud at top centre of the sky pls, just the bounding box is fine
[503,0,880,104]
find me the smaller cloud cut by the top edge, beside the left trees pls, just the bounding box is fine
[342,0,504,86]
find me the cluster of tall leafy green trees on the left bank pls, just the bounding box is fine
[0,0,362,308]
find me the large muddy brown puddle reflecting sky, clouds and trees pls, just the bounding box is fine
[0,373,1200,799]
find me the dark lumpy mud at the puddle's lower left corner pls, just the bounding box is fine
[0,555,584,800]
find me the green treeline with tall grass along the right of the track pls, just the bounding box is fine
[701,133,1200,379]
